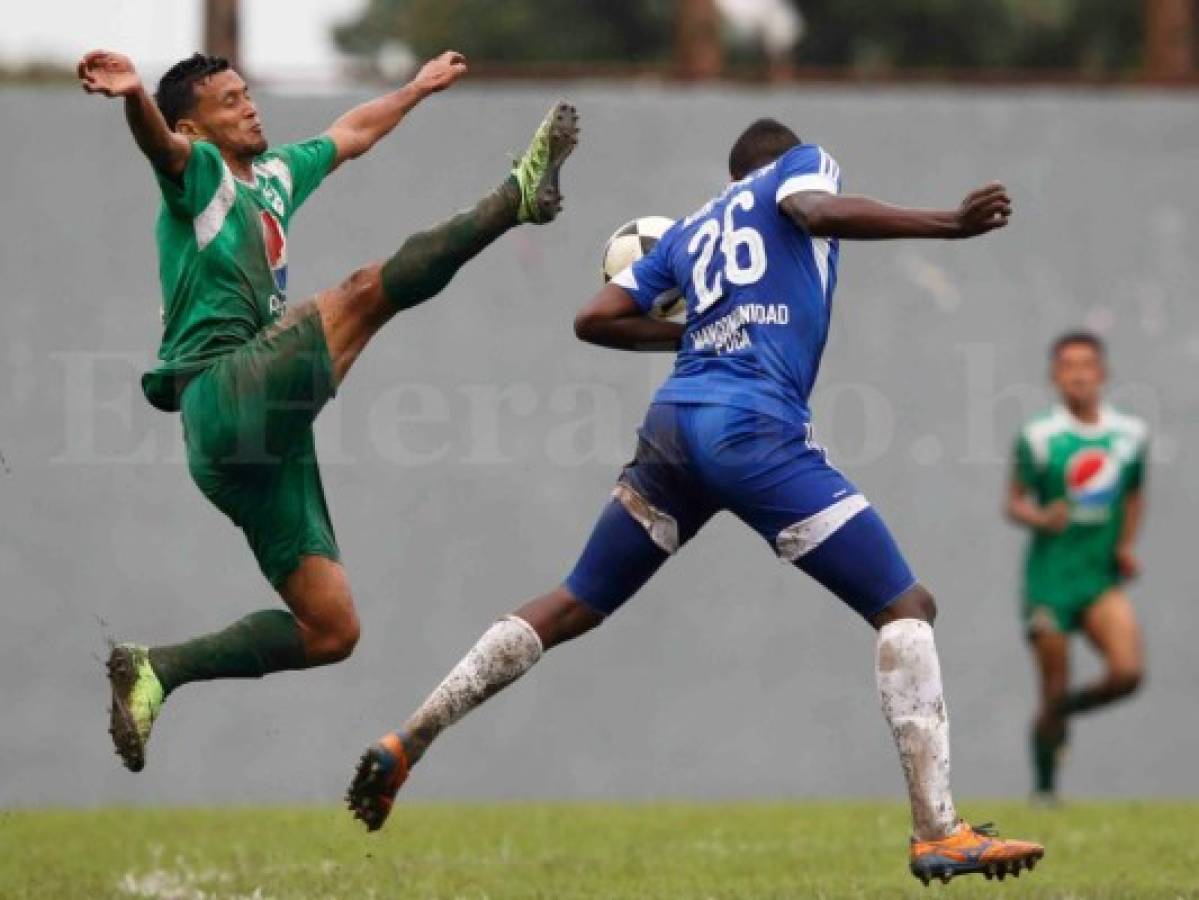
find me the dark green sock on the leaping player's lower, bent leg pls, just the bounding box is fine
[150,610,308,694]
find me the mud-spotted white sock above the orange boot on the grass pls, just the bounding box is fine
[875,618,957,840]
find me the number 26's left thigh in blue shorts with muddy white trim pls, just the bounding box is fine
[565,405,716,616]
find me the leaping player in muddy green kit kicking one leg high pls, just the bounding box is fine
[78,50,578,772]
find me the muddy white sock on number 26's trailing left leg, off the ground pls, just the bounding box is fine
[403,616,542,763]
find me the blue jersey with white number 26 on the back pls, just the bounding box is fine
[613,144,840,422]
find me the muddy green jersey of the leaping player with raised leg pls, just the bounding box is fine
[141,137,336,411]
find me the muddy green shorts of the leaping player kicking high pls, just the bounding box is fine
[181,303,338,587]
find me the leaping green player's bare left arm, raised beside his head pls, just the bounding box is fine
[76,50,192,179]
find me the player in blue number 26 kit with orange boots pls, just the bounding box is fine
[348,120,1044,883]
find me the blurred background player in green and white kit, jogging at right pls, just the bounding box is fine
[1007,332,1147,799]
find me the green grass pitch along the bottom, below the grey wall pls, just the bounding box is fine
[0,803,1199,900]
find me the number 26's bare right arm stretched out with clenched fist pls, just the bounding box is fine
[779,182,1012,241]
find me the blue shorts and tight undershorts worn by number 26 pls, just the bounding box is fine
[566,403,916,618]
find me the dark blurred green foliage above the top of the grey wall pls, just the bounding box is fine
[336,0,1145,74]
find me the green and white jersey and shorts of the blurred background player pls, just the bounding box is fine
[1016,406,1149,606]
